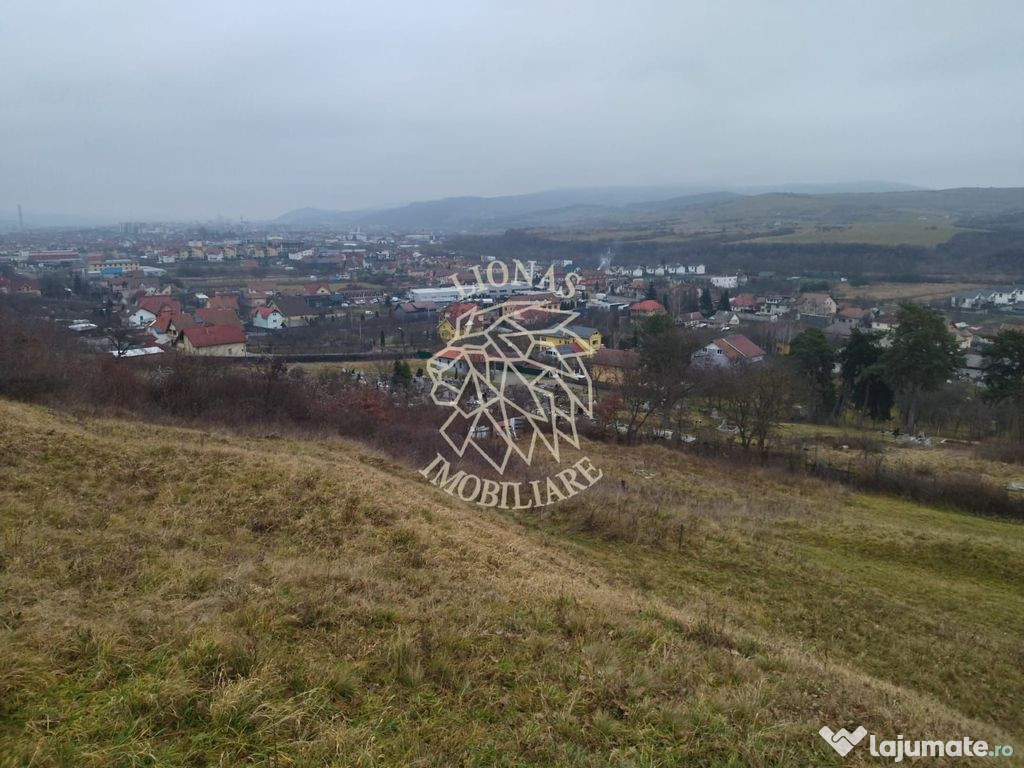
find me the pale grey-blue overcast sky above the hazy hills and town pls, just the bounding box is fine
[0,0,1024,220]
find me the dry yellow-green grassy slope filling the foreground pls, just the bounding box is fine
[0,401,1024,766]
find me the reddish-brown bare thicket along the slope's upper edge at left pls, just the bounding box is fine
[0,309,445,462]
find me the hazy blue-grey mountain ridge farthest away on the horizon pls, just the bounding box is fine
[278,182,1024,231]
